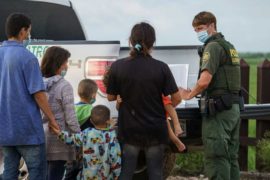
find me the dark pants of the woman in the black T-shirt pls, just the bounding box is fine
[119,144,165,180]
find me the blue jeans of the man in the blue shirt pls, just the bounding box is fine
[2,144,46,180]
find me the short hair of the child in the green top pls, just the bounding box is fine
[78,79,98,99]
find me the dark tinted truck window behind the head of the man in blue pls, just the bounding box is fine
[0,0,86,42]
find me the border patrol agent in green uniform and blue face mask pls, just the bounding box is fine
[180,12,241,180]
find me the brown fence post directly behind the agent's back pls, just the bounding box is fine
[239,59,249,171]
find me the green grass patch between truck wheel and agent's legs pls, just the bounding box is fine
[173,151,204,176]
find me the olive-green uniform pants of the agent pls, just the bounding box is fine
[202,104,240,180]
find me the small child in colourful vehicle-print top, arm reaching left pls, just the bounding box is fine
[51,105,121,180]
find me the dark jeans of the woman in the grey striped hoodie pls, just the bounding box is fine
[47,160,66,180]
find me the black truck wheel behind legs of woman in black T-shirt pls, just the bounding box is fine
[133,148,176,180]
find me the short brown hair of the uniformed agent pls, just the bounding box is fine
[192,11,217,30]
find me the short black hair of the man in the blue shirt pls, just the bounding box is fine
[5,13,31,38]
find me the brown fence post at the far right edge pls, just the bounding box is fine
[256,59,270,170]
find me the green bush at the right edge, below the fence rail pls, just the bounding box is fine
[257,131,270,172]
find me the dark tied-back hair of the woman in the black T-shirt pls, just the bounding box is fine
[129,22,156,57]
